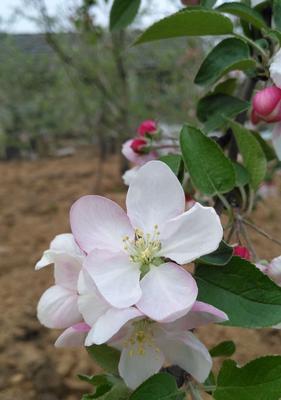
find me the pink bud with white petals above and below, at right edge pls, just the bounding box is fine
[251,50,281,159]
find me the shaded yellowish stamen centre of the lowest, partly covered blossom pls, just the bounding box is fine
[124,319,160,356]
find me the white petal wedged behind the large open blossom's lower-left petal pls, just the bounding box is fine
[78,270,111,326]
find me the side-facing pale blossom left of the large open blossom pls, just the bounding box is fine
[35,233,85,329]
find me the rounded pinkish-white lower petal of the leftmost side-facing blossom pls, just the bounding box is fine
[37,285,82,329]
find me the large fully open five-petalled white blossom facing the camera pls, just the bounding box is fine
[70,161,223,322]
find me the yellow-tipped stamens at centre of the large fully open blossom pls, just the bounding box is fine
[123,225,161,267]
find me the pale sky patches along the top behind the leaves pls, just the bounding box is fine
[0,0,180,33]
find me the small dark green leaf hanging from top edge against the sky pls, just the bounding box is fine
[110,0,141,31]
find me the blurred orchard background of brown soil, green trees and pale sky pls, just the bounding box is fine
[0,0,281,400]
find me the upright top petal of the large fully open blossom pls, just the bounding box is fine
[127,161,185,233]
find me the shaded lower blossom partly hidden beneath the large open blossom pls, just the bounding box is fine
[88,302,228,389]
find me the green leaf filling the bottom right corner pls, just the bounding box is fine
[214,356,281,400]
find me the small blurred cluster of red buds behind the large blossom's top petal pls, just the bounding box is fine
[122,120,179,185]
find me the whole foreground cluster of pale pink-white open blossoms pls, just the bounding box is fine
[36,161,227,389]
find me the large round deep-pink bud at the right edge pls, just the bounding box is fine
[251,86,281,124]
